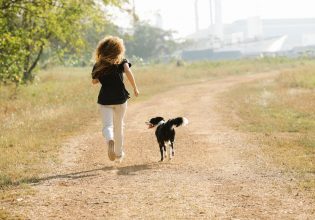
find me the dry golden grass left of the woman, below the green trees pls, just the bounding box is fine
[0,69,97,186]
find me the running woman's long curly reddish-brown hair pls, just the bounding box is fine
[92,36,125,78]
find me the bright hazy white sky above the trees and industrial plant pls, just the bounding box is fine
[128,0,315,36]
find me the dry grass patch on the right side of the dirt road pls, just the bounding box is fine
[225,60,315,196]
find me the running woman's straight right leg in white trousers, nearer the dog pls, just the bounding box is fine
[114,102,127,157]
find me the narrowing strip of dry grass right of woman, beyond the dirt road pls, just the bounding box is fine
[130,58,302,101]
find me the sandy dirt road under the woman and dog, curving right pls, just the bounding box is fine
[6,73,315,219]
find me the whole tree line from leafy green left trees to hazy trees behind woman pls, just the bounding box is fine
[0,0,183,85]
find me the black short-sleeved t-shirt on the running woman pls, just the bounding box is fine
[92,59,131,105]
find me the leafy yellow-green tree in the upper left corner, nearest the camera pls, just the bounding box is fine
[0,0,126,84]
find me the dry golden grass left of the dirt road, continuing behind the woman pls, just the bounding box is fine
[0,58,313,217]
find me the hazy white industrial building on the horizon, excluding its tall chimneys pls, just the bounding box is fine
[183,17,315,59]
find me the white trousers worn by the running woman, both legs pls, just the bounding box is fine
[100,102,127,156]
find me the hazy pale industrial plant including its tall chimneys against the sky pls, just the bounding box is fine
[182,0,315,60]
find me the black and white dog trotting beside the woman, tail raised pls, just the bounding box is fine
[146,117,188,161]
